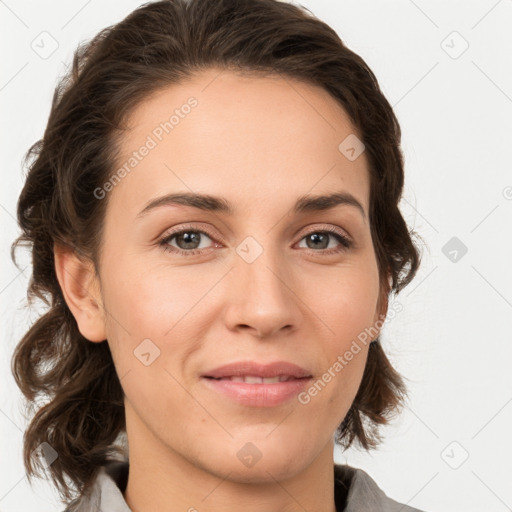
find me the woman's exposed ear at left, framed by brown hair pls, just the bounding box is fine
[53,243,106,342]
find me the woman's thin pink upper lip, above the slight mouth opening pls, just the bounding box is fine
[202,361,311,379]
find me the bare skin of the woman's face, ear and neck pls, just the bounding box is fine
[55,69,387,512]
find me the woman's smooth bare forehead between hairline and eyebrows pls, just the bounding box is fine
[107,69,369,216]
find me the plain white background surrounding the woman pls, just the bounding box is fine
[0,0,512,512]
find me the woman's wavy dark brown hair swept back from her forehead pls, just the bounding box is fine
[11,0,420,500]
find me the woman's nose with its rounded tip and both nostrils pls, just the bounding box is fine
[225,244,302,339]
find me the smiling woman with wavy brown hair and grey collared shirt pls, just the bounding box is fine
[13,0,420,512]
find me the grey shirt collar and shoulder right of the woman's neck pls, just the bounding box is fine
[334,464,425,512]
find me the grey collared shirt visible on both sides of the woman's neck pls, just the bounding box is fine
[64,461,423,512]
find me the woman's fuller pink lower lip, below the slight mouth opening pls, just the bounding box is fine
[202,377,311,407]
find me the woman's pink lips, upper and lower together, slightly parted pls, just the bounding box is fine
[201,361,312,407]
